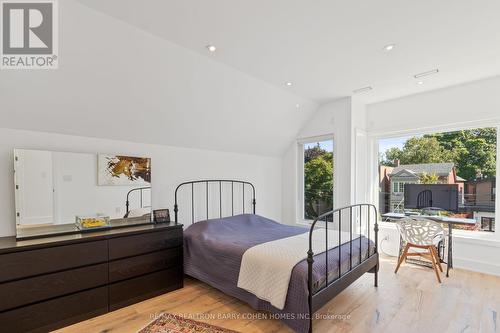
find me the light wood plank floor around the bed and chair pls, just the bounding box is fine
[58,258,500,333]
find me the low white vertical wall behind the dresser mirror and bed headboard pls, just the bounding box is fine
[0,129,282,236]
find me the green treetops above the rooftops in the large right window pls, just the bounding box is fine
[380,128,497,179]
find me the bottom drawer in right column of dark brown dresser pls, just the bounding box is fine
[109,266,184,311]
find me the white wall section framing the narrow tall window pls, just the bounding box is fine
[282,98,352,224]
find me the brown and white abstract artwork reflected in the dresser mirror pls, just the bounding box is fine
[97,155,151,186]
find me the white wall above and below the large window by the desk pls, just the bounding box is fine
[363,77,500,275]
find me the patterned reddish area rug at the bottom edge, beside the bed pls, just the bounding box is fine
[138,313,239,333]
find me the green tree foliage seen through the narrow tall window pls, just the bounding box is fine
[304,145,333,219]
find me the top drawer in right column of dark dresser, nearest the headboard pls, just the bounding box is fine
[109,228,182,260]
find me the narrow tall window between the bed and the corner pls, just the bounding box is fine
[300,137,333,220]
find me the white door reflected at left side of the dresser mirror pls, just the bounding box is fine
[14,149,54,226]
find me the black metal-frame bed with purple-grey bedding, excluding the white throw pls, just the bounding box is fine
[174,180,379,332]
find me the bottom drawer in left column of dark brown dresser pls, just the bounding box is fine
[0,287,108,333]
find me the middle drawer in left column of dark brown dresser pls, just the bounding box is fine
[0,264,108,311]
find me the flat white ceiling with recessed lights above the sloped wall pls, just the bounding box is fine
[79,0,500,103]
